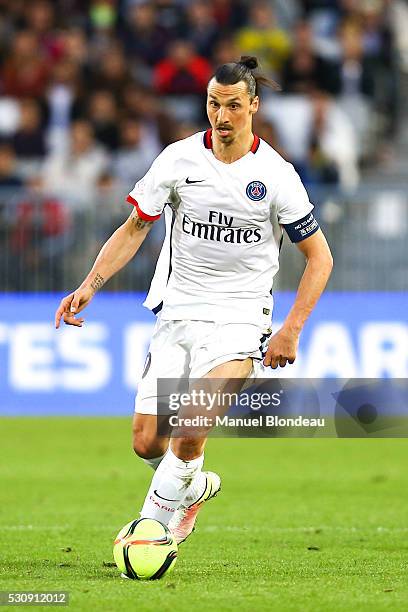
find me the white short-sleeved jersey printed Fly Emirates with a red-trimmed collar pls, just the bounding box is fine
[128,130,318,325]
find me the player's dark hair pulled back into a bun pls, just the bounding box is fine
[213,55,281,99]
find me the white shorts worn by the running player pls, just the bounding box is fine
[135,318,271,415]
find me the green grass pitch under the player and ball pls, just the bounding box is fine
[0,418,408,612]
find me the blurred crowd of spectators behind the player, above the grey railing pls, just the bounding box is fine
[0,0,408,290]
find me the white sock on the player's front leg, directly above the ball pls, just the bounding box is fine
[140,448,204,525]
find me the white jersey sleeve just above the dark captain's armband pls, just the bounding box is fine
[274,163,313,225]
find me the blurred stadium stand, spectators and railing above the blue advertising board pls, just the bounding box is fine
[0,0,408,291]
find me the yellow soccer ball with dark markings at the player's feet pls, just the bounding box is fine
[113,518,177,580]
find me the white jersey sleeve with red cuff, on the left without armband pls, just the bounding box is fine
[126,148,175,221]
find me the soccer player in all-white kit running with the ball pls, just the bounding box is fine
[56,57,332,542]
